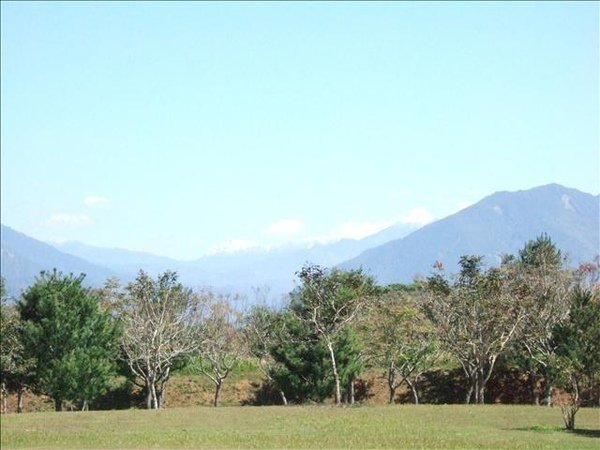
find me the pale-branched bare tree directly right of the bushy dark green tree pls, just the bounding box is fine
[120,271,204,409]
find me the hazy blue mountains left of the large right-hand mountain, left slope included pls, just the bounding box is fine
[1,220,416,301]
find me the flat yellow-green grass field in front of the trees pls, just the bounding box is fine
[1,405,600,449]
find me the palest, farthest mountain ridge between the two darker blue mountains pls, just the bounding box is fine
[53,224,416,299]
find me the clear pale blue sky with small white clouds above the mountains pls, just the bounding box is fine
[0,2,600,259]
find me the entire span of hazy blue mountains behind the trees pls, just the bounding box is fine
[1,184,600,301]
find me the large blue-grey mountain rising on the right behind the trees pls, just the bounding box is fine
[339,184,600,284]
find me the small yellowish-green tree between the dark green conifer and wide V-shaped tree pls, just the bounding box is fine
[367,288,437,404]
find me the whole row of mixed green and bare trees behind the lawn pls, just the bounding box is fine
[2,235,600,427]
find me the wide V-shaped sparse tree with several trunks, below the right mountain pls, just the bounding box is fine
[425,256,526,403]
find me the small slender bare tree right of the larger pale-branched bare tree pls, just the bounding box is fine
[195,298,245,407]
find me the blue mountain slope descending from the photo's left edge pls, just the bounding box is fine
[0,225,115,296]
